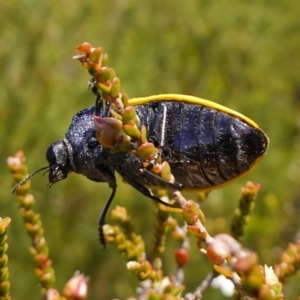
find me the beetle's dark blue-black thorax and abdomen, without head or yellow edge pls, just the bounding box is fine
[65,101,267,190]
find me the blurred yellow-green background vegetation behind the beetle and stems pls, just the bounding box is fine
[0,0,300,299]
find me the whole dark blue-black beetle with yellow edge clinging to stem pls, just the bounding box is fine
[12,94,268,244]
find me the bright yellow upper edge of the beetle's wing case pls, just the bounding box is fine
[128,94,259,128]
